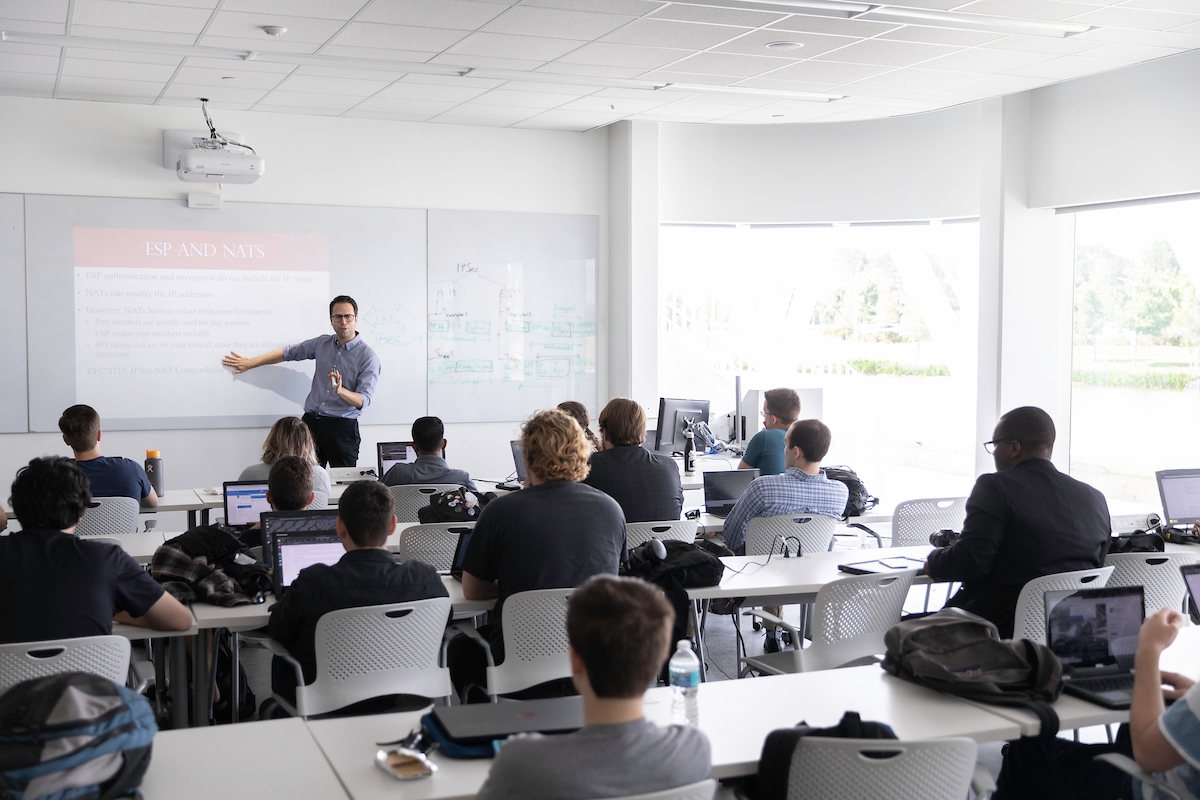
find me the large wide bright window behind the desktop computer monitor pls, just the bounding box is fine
[659,219,979,505]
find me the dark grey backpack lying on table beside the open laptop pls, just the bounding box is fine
[883,608,1062,739]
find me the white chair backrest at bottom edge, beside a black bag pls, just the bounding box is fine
[787,736,976,800]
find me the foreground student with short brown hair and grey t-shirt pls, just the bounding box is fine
[475,576,712,800]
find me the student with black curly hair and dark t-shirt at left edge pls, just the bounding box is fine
[0,456,192,644]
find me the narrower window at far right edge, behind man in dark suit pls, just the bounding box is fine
[1070,200,1200,507]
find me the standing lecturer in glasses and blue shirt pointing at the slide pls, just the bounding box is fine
[221,295,379,467]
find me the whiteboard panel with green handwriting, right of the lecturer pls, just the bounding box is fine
[427,210,600,422]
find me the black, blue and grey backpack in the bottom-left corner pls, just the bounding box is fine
[0,672,158,800]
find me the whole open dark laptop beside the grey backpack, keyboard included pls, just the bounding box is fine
[1045,587,1146,709]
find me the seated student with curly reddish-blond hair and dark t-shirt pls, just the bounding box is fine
[448,410,625,699]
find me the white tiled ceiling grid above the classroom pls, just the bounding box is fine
[0,0,1200,131]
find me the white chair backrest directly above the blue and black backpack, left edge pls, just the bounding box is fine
[0,636,130,694]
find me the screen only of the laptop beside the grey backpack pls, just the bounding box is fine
[1045,587,1146,668]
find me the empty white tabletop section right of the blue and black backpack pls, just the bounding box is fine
[142,718,350,800]
